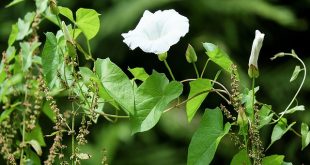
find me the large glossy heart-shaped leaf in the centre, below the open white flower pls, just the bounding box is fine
[130,71,183,133]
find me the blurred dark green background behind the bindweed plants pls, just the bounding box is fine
[0,0,310,165]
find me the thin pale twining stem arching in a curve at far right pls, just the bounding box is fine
[273,53,307,123]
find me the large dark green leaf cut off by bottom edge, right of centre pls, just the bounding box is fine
[187,107,231,165]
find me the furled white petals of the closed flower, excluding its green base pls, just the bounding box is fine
[249,30,265,69]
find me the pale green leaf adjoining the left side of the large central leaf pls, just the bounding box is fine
[95,58,134,114]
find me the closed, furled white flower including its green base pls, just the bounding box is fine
[248,30,265,78]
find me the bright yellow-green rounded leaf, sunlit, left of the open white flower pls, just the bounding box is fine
[76,8,100,40]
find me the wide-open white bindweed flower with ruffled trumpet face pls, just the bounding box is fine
[122,9,189,54]
